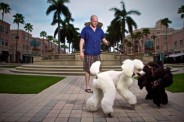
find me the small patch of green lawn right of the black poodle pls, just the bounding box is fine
[166,74,184,93]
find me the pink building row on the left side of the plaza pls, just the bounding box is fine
[0,20,58,63]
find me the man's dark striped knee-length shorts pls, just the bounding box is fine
[83,55,100,73]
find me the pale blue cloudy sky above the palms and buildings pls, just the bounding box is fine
[0,0,184,37]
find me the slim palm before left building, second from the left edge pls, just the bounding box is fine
[13,13,24,62]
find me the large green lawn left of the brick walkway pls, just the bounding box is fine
[0,74,64,94]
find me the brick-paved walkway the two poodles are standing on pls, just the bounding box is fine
[0,70,184,122]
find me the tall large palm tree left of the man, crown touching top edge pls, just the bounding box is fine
[46,0,71,54]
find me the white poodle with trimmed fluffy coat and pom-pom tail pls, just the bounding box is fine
[86,59,144,116]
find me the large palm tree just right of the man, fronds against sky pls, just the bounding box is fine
[110,1,141,50]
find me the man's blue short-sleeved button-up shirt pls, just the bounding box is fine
[80,26,105,55]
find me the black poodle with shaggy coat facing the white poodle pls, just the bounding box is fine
[138,62,173,107]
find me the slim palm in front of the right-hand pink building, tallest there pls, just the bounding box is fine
[161,18,172,54]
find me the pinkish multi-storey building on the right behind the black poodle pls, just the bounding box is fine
[125,20,184,55]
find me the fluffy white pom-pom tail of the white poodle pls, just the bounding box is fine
[90,61,101,75]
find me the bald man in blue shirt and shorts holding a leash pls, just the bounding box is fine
[79,15,109,93]
